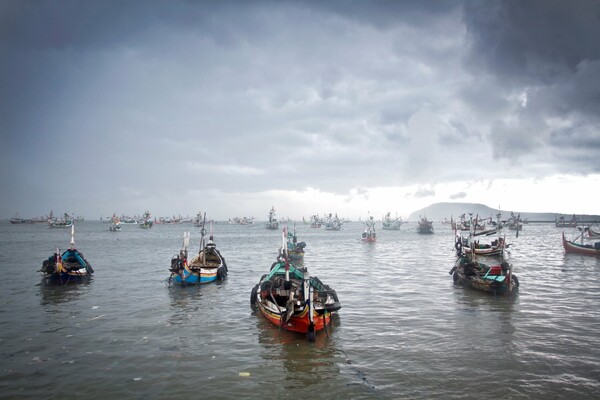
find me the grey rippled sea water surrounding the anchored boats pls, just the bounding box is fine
[0,221,600,400]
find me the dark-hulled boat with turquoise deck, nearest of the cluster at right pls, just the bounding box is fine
[450,254,519,294]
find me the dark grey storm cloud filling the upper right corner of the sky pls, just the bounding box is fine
[463,0,600,172]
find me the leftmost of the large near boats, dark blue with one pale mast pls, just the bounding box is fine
[40,226,94,284]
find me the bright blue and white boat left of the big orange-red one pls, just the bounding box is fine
[168,214,228,286]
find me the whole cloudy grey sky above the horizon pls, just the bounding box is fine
[0,0,600,220]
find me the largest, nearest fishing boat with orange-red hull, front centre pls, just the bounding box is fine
[250,228,342,341]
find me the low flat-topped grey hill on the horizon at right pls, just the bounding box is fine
[408,202,600,222]
